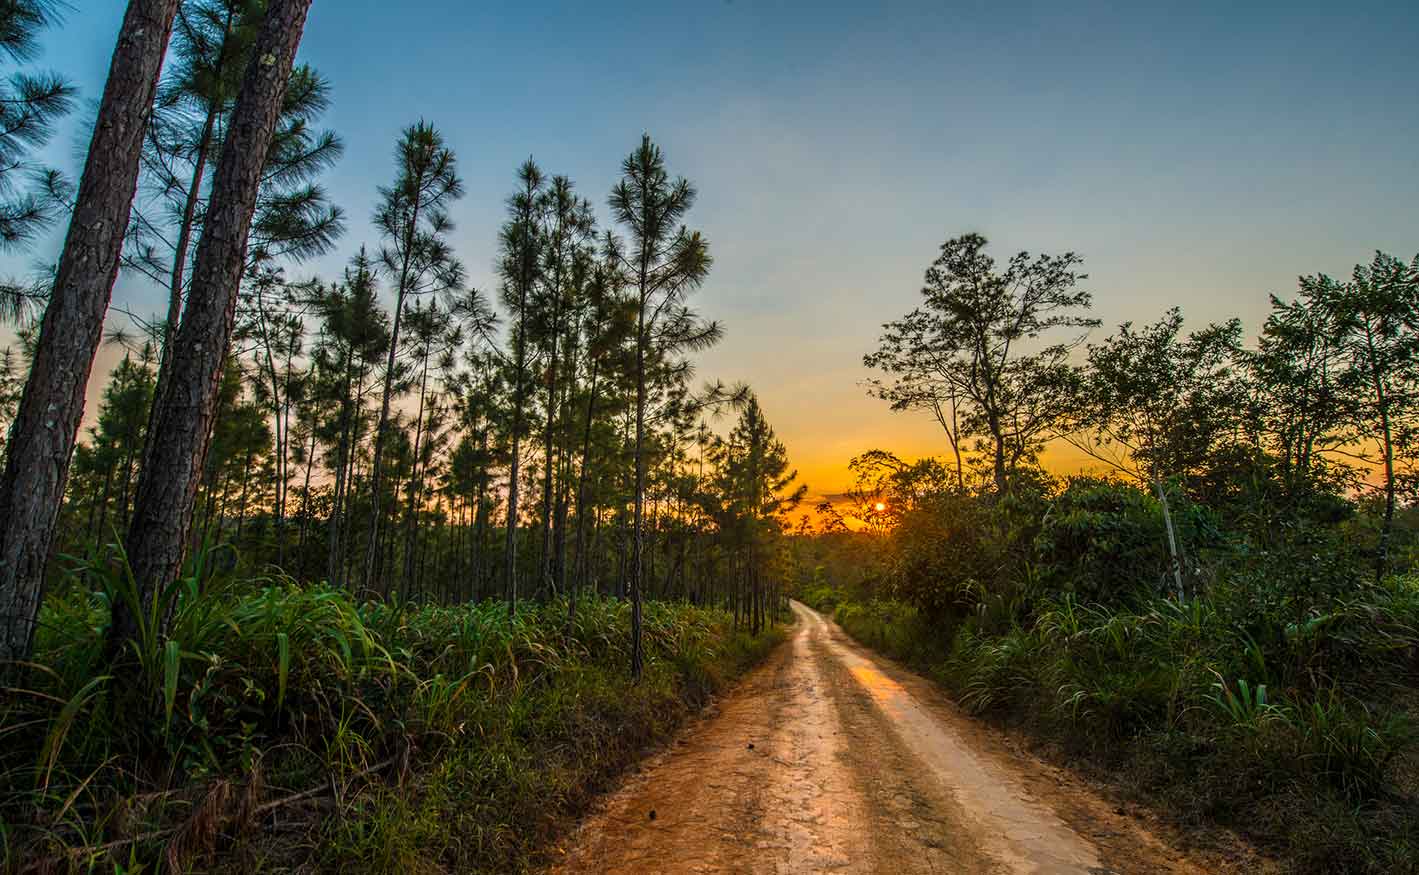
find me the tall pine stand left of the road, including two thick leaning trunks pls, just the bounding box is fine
[0,0,805,676]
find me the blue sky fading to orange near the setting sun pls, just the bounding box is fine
[0,0,1419,495]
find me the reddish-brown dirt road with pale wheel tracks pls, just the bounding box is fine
[555,603,1220,875]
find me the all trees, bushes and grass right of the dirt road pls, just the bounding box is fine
[795,237,1419,874]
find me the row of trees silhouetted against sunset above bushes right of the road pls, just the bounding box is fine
[857,234,1419,594]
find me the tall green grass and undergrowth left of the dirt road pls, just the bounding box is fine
[0,570,780,874]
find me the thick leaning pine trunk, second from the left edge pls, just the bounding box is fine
[111,0,311,641]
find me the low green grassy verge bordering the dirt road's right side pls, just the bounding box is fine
[809,579,1419,874]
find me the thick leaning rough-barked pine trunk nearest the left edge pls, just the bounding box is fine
[0,0,179,661]
